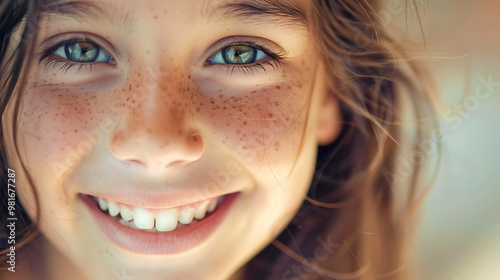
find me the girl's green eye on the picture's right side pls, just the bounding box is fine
[208,45,269,65]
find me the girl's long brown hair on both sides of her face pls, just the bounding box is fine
[0,0,438,280]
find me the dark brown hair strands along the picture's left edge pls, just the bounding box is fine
[0,0,40,274]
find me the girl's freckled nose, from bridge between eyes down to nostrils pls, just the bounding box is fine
[110,60,203,171]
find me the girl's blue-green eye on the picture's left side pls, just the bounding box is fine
[53,41,111,62]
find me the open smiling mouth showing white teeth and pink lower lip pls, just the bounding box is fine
[78,192,241,255]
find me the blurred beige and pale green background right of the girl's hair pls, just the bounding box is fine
[378,0,500,280]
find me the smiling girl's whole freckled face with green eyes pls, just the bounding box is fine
[3,0,340,279]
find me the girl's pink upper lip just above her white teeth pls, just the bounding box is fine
[81,191,230,208]
